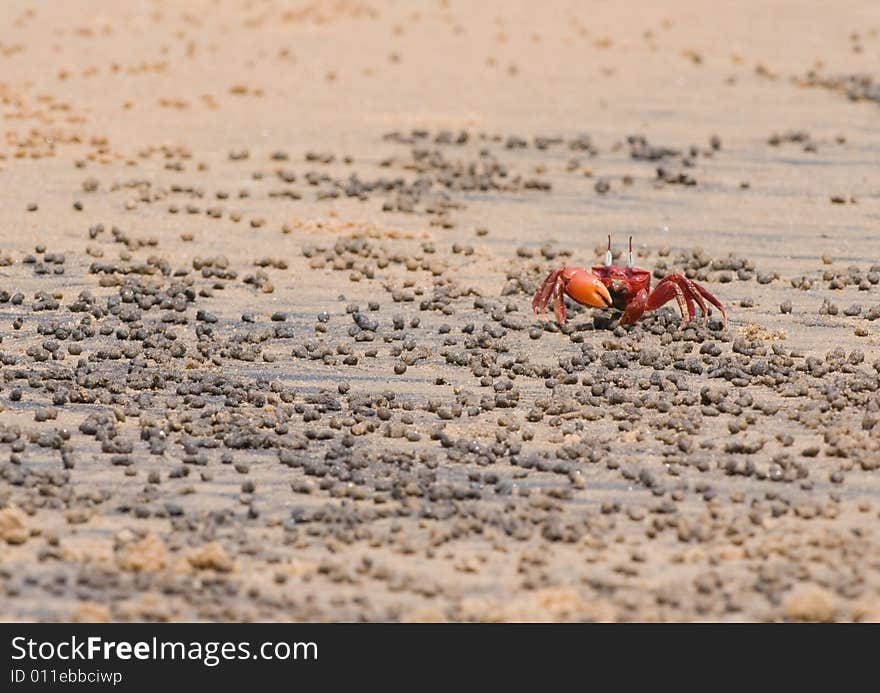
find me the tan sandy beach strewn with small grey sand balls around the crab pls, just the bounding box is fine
[0,0,880,621]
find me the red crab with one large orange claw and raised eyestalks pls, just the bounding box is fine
[532,236,727,327]
